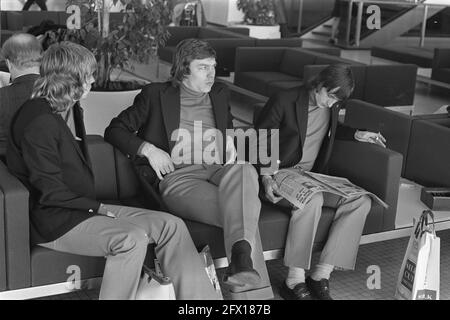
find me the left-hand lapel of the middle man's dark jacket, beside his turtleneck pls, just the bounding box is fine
[161,85,180,150]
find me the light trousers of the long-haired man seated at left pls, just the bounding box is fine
[40,205,219,300]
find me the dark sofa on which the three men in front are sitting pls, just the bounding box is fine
[0,136,402,294]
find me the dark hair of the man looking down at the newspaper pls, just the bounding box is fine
[307,64,355,101]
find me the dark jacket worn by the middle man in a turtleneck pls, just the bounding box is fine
[105,82,233,208]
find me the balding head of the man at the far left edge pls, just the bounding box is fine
[2,33,42,70]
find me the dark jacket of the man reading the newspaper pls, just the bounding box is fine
[255,86,356,173]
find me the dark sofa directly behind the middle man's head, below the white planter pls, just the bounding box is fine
[158,27,340,75]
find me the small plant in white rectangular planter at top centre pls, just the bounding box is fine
[236,0,280,39]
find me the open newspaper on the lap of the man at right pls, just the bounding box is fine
[274,168,388,209]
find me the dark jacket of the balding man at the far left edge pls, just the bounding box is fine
[0,74,39,155]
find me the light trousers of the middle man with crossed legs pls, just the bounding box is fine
[159,163,270,286]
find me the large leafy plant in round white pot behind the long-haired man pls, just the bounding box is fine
[44,0,171,135]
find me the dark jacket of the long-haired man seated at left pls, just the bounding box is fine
[6,98,100,244]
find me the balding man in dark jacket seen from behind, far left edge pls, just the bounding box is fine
[0,33,42,155]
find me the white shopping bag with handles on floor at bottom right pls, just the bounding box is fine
[395,210,440,300]
